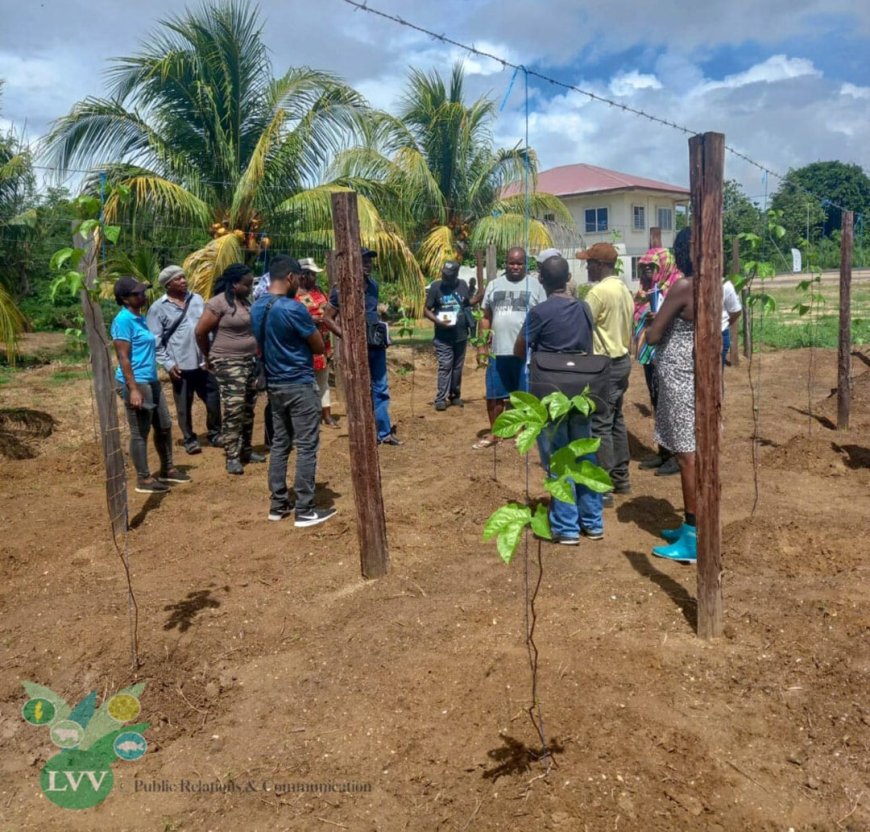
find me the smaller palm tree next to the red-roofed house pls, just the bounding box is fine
[332,63,574,277]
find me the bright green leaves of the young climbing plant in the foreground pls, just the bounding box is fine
[483,388,613,563]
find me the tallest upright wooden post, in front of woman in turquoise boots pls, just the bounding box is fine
[689,133,725,639]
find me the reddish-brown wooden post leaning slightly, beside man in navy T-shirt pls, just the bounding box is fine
[332,191,390,578]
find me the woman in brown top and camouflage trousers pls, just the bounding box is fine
[196,263,266,474]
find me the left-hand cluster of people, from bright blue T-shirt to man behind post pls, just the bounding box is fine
[111,249,401,527]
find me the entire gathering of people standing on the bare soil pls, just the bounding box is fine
[112,230,740,562]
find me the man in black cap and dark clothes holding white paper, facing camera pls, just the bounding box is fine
[423,260,473,411]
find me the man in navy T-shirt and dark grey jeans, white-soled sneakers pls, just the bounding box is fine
[251,255,335,527]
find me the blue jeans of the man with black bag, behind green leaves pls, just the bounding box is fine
[538,412,604,538]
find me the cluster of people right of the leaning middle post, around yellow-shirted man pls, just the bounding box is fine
[426,234,742,563]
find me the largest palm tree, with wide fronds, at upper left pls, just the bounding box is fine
[46,0,421,295]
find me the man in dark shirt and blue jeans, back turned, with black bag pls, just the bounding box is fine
[514,257,604,546]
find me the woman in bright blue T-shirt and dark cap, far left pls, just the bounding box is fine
[112,277,190,494]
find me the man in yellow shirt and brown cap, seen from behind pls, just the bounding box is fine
[577,243,634,506]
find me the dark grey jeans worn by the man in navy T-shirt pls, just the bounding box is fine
[269,382,320,511]
